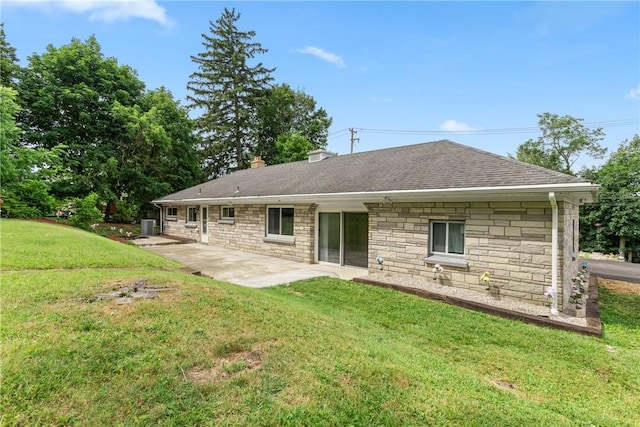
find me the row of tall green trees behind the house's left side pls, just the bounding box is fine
[0,9,332,222]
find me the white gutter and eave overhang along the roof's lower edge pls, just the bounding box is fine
[153,182,599,205]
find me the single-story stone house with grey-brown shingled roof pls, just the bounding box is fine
[153,140,598,311]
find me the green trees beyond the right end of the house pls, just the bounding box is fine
[515,112,640,262]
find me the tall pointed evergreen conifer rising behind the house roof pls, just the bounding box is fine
[187,8,275,177]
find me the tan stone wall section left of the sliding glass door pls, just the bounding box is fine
[164,204,316,264]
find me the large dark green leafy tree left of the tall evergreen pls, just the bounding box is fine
[18,36,144,198]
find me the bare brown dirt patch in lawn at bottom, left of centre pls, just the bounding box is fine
[185,351,262,384]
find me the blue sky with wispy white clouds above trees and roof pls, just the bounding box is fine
[0,0,640,171]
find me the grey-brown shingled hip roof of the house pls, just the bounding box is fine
[154,140,592,203]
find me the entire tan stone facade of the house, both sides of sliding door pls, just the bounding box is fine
[163,200,579,309]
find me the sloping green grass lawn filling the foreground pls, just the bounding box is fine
[0,220,640,426]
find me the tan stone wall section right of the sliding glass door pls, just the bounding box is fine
[367,202,577,306]
